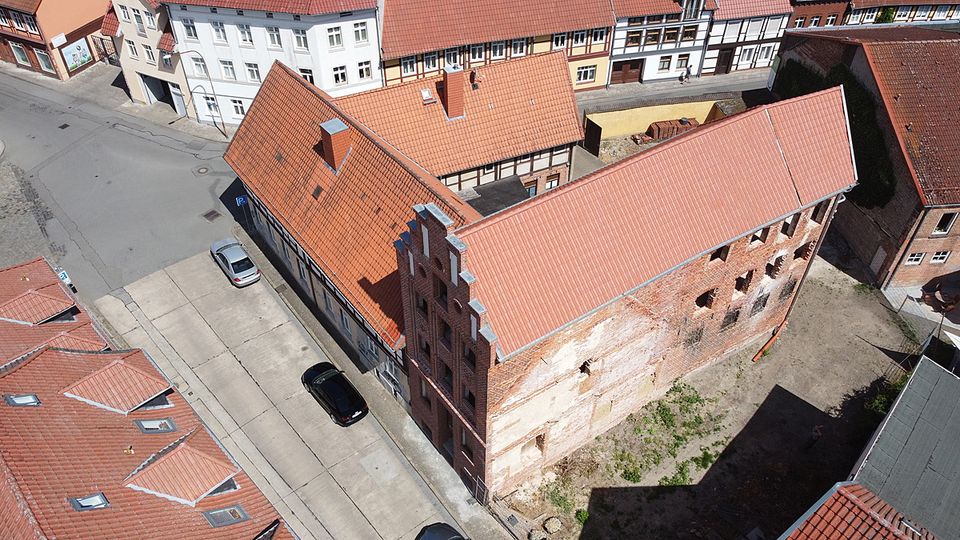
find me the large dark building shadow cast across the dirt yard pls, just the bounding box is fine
[581,379,882,540]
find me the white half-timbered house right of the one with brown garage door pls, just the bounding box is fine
[703,0,793,75]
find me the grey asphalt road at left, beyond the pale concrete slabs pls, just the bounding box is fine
[0,70,235,303]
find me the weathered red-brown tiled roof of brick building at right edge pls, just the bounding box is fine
[863,35,960,205]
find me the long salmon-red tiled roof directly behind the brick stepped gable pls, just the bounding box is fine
[456,88,856,355]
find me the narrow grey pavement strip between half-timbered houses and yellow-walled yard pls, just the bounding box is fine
[577,69,770,114]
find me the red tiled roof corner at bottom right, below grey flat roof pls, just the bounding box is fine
[781,482,935,540]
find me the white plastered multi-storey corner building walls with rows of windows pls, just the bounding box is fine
[167,0,383,125]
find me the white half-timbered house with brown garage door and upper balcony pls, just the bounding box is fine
[608,0,714,84]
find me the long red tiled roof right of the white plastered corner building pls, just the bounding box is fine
[383,0,614,59]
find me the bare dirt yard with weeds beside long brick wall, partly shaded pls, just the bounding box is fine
[507,237,909,539]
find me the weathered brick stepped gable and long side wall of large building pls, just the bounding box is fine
[397,199,835,493]
